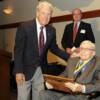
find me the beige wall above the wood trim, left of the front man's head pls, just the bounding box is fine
[0,0,37,25]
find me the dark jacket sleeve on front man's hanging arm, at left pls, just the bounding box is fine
[14,25,25,74]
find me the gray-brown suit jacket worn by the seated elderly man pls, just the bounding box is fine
[61,57,100,93]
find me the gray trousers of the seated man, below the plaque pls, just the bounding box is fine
[40,90,100,100]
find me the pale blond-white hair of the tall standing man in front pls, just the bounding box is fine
[37,1,53,13]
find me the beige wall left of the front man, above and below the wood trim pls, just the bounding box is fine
[0,0,37,57]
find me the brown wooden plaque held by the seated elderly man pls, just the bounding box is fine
[44,74,74,93]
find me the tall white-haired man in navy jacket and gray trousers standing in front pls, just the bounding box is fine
[14,1,69,100]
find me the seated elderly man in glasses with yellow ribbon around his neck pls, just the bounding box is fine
[40,40,100,100]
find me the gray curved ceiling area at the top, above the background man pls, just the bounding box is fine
[47,0,94,11]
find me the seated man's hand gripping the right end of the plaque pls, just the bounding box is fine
[65,82,84,92]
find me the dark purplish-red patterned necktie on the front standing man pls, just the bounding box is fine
[39,26,44,55]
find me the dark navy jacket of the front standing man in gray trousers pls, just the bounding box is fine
[14,20,68,80]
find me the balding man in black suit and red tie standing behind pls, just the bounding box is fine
[61,8,95,54]
